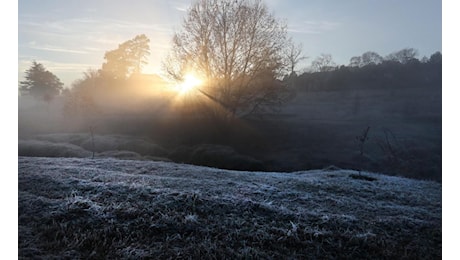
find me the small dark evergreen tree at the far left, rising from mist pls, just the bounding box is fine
[19,61,64,103]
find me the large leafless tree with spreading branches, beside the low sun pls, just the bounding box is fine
[163,0,292,116]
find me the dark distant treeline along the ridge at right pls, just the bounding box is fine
[283,49,442,91]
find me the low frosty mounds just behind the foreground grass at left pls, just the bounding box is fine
[18,133,265,171]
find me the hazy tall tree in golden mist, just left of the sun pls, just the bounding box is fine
[102,34,150,79]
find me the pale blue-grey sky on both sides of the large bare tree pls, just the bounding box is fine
[18,0,442,86]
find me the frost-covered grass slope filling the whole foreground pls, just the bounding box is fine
[18,157,442,259]
